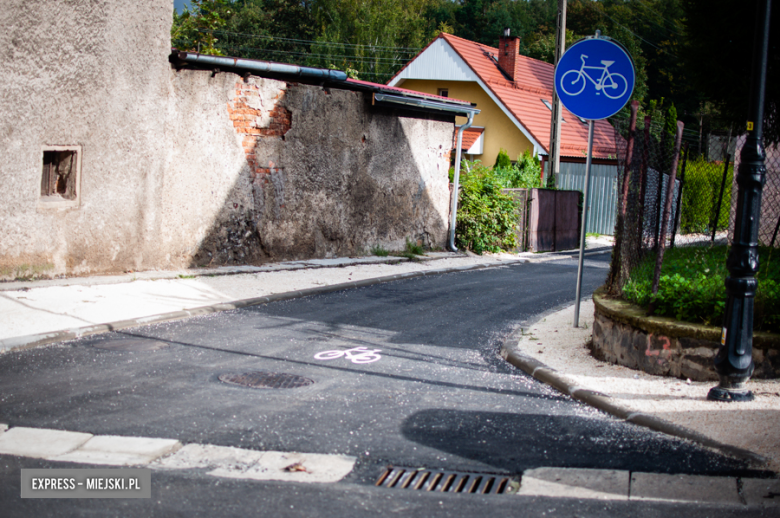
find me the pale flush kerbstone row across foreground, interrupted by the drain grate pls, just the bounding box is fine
[0,424,780,509]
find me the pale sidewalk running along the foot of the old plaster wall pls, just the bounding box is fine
[0,252,544,353]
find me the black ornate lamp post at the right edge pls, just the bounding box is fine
[707,0,772,401]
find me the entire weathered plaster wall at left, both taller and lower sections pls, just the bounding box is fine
[0,0,453,279]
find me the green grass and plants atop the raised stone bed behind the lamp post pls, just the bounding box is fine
[623,246,780,333]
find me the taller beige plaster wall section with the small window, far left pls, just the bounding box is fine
[0,0,172,278]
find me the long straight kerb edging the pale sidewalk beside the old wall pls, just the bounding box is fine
[0,258,528,354]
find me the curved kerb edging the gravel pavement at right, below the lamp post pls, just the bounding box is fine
[501,345,769,467]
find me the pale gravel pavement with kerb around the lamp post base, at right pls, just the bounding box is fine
[501,300,780,472]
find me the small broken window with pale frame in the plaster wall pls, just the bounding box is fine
[40,146,81,207]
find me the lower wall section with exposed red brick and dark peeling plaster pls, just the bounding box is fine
[169,75,453,266]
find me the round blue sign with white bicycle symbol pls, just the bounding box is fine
[555,38,634,120]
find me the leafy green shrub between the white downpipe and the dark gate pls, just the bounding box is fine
[456,160,517,254]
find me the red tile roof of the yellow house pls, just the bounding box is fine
[391,33,616,158]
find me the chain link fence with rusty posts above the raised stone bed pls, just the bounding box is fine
[607,112,780,296]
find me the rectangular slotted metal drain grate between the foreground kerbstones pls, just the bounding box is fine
[376,466,520,495]
